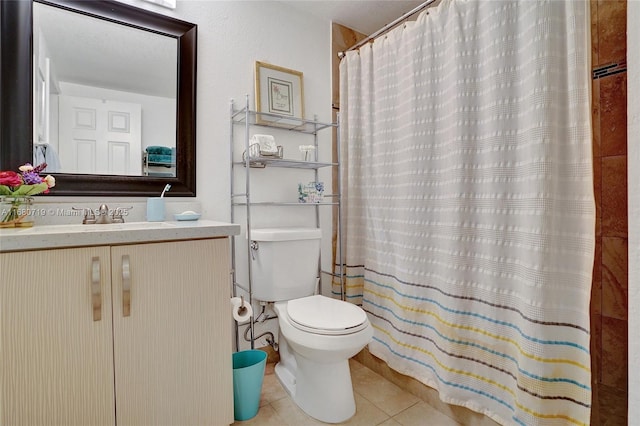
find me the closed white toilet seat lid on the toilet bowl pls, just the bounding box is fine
[287,295,368,335]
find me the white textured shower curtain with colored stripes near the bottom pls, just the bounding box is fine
[333,0,595,425]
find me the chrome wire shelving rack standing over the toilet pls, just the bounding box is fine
[229,96,345,349]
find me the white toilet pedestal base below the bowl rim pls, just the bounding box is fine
[275,354,356,423]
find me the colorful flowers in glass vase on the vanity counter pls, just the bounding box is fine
[0,163,56,228]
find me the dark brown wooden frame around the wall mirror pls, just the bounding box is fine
[0,0,197,196]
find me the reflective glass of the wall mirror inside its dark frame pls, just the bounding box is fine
[33,2,179,176]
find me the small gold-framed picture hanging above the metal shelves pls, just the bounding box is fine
[255,61,304,126]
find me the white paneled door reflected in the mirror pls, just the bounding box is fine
[59,96,142,176]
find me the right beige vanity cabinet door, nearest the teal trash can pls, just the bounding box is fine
[111,238,233,426]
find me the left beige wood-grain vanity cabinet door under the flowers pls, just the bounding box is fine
[0,247,115,426]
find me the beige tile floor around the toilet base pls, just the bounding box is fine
[234,360,459,426]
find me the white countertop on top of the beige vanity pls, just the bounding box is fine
[0,220,240,253]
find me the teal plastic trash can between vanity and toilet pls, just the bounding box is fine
[233,349,267,421]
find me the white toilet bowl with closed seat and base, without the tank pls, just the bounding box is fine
[274,295,373,423]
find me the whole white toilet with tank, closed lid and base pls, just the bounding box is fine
[251,228,373,423]
